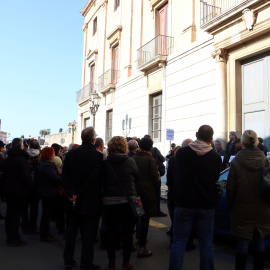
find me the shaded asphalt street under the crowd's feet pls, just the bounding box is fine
[0,200,270,270]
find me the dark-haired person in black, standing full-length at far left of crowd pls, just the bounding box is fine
[3,138,33,246]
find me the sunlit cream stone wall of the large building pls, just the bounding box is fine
[78,0,270,154]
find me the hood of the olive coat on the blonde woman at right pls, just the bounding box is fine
[232,148,266,170]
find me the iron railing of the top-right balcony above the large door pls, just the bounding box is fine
[200,0,252,26]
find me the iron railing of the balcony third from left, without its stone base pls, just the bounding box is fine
[137,35,174,68]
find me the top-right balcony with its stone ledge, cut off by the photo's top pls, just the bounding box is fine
[200,0,259,28]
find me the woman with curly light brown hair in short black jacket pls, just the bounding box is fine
[102,136,139,270]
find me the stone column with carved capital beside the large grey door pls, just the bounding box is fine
[211,48,228,149]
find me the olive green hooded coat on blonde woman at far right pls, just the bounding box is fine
[227,148,270,239]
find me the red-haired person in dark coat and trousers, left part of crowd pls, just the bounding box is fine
[38,147,62,242]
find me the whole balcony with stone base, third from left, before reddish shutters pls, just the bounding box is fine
[137,35,174,71]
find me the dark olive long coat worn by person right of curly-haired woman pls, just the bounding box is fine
[132,152,159,217]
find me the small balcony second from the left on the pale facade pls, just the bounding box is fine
[98,69,120,94]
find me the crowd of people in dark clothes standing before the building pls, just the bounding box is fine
[0,125,270,270]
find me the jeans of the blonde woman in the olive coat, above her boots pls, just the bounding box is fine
[236,228,265,255]
